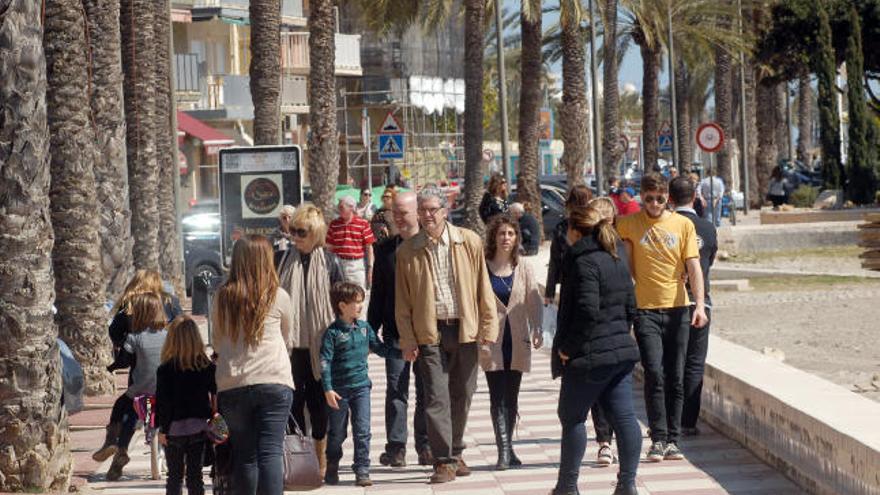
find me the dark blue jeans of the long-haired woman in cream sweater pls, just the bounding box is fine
[218,383,293,495]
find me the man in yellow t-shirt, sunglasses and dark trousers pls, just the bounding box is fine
[617,173,708,462]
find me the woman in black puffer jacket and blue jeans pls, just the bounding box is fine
[553,207,642,495]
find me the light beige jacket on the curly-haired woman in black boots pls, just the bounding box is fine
[480,263,544,373]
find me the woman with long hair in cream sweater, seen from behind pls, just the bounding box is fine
[211,235,293,495]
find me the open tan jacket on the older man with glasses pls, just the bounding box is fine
[394,222,498,347]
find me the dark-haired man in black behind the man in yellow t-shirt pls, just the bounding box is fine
[669,177,718,435]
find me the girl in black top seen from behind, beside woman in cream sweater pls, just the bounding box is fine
[156,316,217,495]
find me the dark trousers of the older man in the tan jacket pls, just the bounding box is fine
[416,322,478,463]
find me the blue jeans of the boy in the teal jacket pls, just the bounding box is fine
[327,386,372,473]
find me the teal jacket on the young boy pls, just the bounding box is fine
[321,318,400,392]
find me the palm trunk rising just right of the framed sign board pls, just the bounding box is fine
[308,0,339,219]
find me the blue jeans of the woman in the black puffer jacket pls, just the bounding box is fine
[555,363,642,493]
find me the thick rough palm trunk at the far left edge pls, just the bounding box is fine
[0,0,72,493]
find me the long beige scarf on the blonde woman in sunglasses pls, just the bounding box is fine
[279,247,336,380]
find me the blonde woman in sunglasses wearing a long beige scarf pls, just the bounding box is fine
[280,203,343,476]
